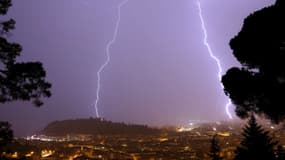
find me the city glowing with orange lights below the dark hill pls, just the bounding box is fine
[1,119,285,160]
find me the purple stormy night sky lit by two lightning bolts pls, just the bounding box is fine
[0,0,274,135]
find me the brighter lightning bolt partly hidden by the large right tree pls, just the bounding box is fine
[197,1,233,119]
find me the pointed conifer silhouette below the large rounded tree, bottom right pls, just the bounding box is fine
[234,115,277,160]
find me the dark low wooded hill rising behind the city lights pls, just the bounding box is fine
[40,118,162,136]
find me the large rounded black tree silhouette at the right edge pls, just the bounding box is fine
[222,0,285,122]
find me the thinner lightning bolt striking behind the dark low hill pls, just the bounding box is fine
[94,0,129,118]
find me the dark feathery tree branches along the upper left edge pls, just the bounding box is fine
[0,0,51,106]
